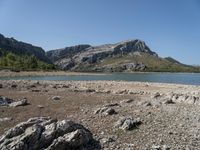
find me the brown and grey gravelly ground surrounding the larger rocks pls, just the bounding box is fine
[0,80,200,150]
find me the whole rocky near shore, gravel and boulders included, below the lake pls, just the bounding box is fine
[0,80,200,150]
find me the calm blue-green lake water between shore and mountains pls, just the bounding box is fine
[0,73,200,85]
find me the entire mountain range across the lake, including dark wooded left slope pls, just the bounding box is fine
[0,34,200,72]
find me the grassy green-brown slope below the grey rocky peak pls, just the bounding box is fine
[95,53,200,72]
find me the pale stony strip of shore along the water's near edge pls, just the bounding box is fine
[0,80,200,95]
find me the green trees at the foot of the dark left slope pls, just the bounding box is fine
[0,50,55,70]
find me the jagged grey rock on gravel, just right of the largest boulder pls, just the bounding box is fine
[115,117,142,131]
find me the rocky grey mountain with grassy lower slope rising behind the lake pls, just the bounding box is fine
[46,39,200,72]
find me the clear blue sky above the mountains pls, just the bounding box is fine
[0,0,200,64]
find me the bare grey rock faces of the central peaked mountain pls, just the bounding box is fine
[47,40,157,71]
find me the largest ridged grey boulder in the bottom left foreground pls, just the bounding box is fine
[0,117,93,150]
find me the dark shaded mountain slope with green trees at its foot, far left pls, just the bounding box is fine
[0,34,54,70]
